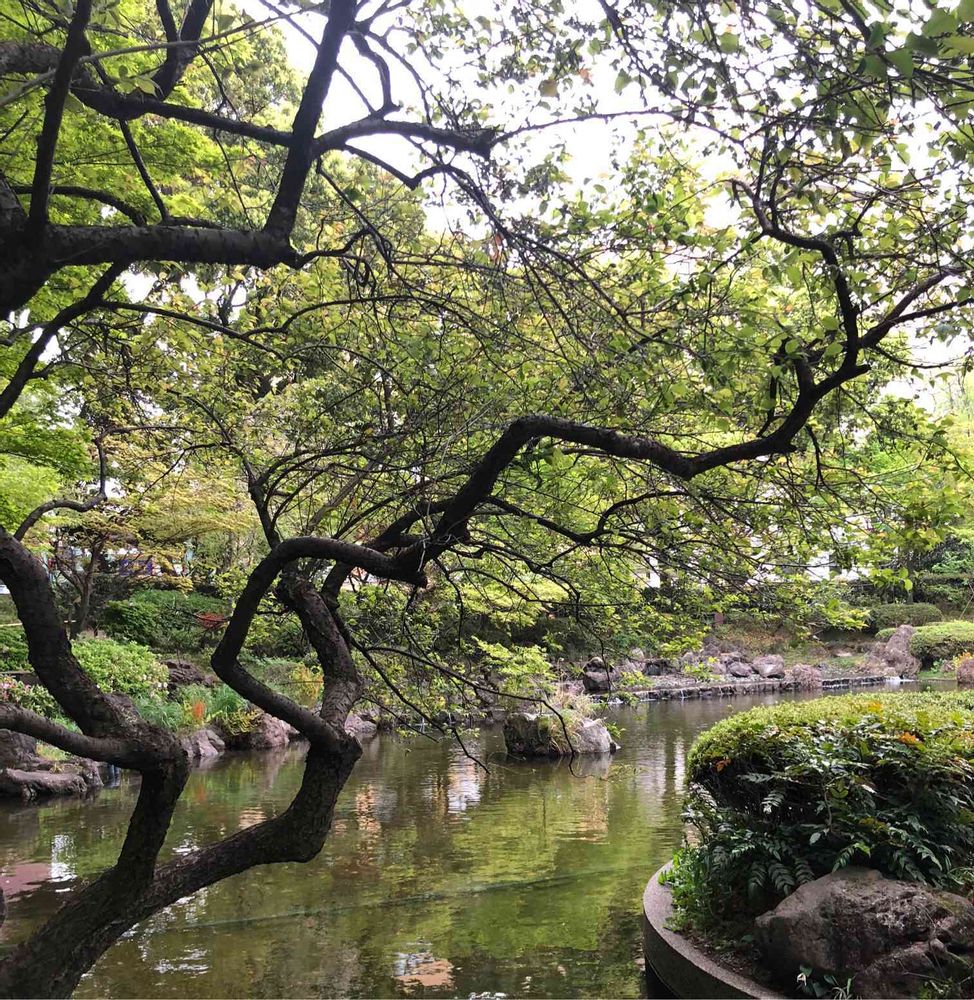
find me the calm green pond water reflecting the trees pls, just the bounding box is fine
[0,696,832,997]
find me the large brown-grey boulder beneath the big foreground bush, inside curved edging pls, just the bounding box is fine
[755,868,974,997]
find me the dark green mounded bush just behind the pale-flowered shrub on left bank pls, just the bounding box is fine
[102,590,227,652]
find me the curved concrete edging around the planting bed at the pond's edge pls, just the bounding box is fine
[643,865,784,1000]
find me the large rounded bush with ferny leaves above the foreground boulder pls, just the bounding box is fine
[668,692,974,927]
